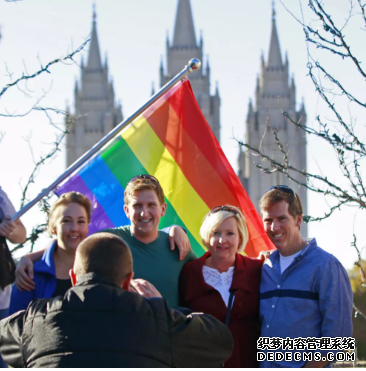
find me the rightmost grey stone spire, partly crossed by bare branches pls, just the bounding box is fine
[238,10,307,237]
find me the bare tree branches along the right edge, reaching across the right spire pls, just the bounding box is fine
[238,0,366,298]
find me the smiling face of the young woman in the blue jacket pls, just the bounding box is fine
[53,202,88,251]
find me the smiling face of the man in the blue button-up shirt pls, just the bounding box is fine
[262,201,305,256]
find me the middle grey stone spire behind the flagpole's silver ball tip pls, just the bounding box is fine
[160,0,220,142]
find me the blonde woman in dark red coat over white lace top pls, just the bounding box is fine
[180,206,262,367]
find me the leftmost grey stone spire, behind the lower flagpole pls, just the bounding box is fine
[66,10,123,167]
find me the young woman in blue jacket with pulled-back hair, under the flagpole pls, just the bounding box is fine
[8,192,92,315]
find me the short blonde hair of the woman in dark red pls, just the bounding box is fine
[200,205,249,252]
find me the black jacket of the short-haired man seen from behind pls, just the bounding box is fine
[0,273,233,367]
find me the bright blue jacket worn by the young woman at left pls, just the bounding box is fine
[8,240,57,316]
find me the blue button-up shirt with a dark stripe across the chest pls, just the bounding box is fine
[258,239,353,368]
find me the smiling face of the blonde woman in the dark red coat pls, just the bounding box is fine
[208,217,241,266]
